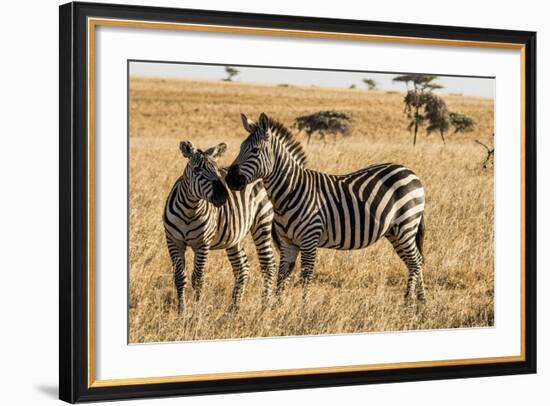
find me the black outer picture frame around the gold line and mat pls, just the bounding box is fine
[59,3,536,403]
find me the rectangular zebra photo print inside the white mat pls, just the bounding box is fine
[128,60,495,344]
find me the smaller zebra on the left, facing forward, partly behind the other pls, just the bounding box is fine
[163,141,275,313]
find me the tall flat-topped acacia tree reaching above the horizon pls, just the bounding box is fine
[393,74,446,145]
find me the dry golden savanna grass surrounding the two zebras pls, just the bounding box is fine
[129,77,494,343]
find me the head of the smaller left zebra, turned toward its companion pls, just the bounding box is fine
[180,141,228,207]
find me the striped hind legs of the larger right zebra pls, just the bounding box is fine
[388,233,425,303]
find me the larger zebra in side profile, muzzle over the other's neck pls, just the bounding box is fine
[226,113,425,302]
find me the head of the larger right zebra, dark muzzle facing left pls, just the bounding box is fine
[225,113,274,190]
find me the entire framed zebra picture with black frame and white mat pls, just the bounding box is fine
[59,3,536,402]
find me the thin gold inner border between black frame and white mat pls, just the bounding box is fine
[87,18,526,388]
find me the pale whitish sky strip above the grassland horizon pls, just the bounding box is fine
[130,61,495,97]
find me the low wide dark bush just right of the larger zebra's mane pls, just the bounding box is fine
[294,110,352,144]
